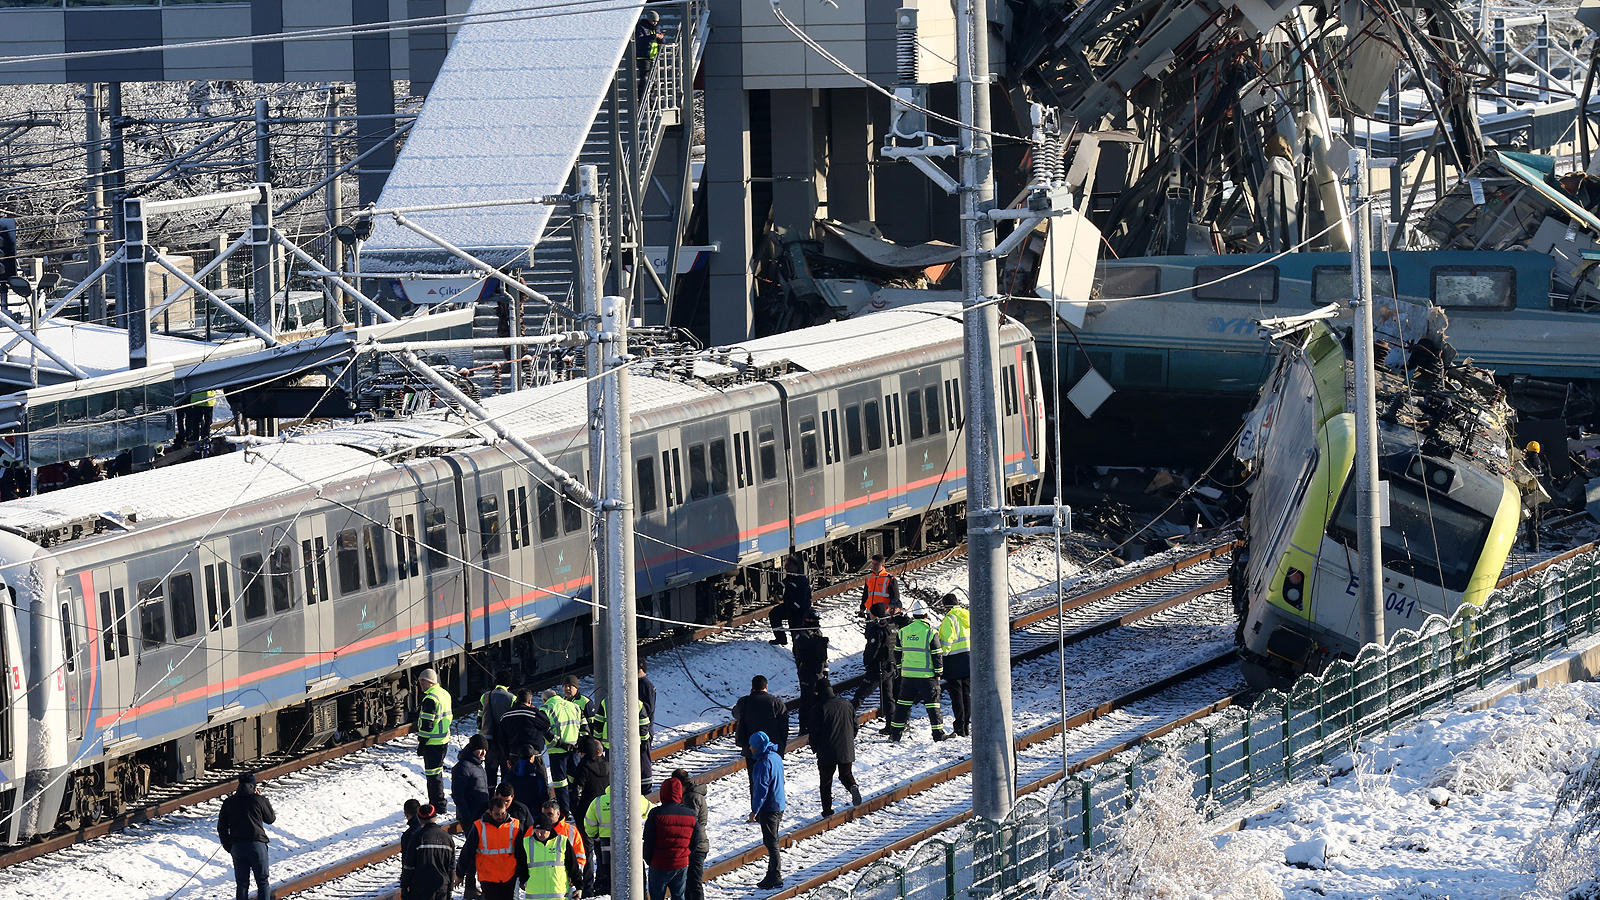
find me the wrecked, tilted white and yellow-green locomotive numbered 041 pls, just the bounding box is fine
[1230,304,1542,687]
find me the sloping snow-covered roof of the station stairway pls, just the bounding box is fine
[362,0,643,272]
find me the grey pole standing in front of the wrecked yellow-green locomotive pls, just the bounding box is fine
[1349,151,1384,644]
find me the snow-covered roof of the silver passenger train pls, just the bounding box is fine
[0,303,962,544]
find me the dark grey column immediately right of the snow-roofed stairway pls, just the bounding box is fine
[702,3,755,344]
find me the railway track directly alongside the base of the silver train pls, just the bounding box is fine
[0,543,966,868]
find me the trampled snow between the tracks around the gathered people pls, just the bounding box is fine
[0,538,1113,900]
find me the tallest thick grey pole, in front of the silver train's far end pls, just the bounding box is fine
[955,0,1016,820]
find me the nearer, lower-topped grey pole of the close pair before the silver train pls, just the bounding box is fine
[589,288,645,900]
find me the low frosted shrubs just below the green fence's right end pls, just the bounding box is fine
[1429,687,1600,796]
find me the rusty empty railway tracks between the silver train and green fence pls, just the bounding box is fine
[265,534,1232,898]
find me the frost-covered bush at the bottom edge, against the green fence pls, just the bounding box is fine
[1058,756,1283,900]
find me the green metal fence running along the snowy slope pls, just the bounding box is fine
[811,549,1600,900]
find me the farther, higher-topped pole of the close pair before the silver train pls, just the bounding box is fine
[576,165,616,704]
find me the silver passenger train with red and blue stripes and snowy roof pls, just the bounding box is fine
[0,303,1045,844]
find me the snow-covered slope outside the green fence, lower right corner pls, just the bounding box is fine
[1242,682,1600,900]
